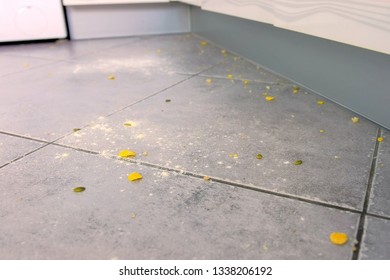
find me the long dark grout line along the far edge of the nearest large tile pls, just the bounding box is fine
[51,143,362,214]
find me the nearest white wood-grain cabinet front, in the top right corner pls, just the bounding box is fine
[274,0,390,54]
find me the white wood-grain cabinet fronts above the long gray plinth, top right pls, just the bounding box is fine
[198,0,390,54]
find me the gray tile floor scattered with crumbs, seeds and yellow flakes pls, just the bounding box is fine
[0,34,390,259]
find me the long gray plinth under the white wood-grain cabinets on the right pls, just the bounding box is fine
[191,7,390,128]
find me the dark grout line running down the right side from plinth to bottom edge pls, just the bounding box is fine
[352,127,382,260]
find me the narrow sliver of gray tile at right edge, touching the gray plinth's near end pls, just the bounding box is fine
[368,130,390,217]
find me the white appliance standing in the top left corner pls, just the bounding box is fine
[0,0,67,42]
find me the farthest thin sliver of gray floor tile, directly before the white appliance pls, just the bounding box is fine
[0,37,140,60]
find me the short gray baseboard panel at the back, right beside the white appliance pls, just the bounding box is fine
[66,3,191,40]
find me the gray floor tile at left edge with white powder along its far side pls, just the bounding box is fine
[0,59,187,140]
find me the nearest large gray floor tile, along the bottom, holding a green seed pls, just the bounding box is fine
[0,146,358,259]
